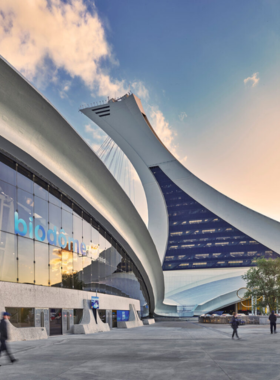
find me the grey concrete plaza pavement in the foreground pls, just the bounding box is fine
[0,322,280,380]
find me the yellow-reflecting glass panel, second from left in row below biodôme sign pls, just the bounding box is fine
[18,236,34,284]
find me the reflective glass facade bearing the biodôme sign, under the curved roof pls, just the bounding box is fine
[0,154,149,316]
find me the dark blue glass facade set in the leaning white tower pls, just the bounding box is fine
[150,167,278,270]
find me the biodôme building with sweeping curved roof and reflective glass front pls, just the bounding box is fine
[0,58,176,335]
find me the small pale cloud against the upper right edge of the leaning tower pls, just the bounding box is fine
[150,107,178,158]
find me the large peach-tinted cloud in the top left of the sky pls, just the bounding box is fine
[0,0,126,97]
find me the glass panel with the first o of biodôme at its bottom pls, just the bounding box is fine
[34,196,48,242]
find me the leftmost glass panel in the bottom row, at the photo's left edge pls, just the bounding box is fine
[0,231,17,282]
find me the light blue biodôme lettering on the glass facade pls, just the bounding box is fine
[15,212,87,256]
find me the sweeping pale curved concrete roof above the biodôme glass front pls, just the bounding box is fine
[0,57,173,312]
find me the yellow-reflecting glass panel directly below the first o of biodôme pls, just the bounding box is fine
[35,241,49,286]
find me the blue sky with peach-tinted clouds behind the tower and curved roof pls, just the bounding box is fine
[0,0,280,222]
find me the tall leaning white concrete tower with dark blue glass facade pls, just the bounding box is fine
[81,94,280,315]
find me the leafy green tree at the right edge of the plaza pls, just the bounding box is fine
[242,258,280,311]
